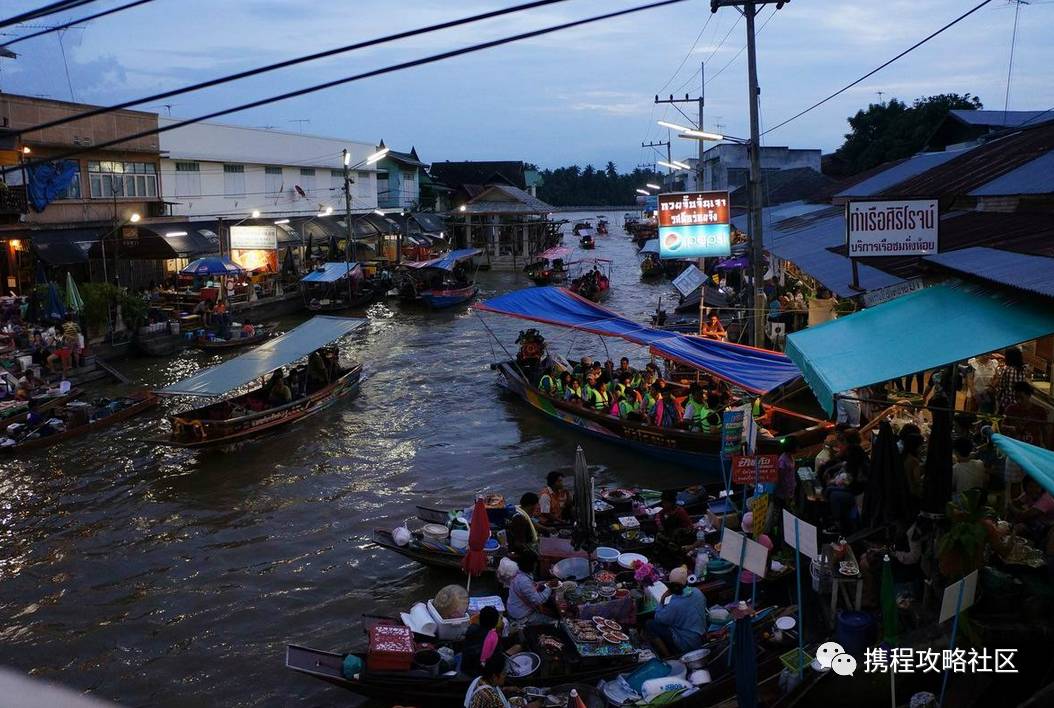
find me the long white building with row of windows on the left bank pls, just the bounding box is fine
[158,118,377,219]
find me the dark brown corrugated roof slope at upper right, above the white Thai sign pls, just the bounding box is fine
[882,123,1054,197]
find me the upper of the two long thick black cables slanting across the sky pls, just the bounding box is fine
[15,0,566,135]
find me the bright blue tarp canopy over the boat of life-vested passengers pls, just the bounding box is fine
[475,288,801,393]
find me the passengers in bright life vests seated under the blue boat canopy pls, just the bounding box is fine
[538,356,733,433]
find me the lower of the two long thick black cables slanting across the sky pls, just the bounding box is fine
[16,0,686,173]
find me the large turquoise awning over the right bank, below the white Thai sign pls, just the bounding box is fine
[786,281,1054,413]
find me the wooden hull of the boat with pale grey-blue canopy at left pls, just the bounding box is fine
[157,366,363,449]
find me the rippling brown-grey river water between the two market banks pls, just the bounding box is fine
[0,212,708,706]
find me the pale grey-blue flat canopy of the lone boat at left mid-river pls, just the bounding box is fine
[158,315,367,396]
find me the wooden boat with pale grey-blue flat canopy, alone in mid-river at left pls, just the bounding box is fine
[156,315,367,448]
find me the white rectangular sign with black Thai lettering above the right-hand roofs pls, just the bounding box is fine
[845,199,940,258]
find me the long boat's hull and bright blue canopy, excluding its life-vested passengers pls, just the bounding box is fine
[475,288,833,474]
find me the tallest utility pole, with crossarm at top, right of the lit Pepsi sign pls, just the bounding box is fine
[710,0,789,348]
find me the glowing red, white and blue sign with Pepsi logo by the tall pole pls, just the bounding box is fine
[659,192,731,258]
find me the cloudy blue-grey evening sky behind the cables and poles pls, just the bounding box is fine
[0,0,1054,171]
